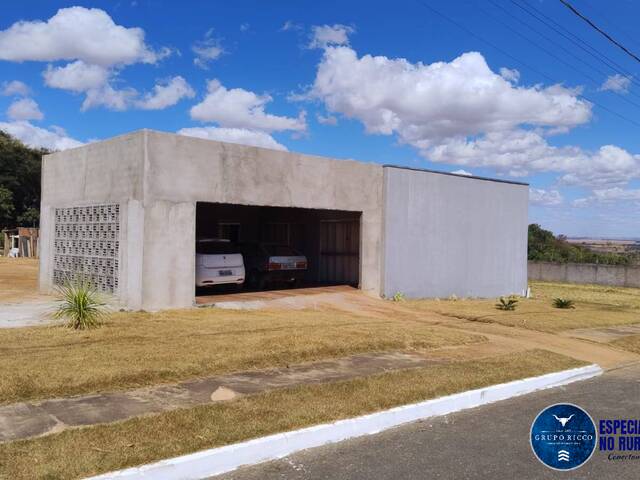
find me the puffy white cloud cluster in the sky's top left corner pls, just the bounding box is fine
[0,7,178,110]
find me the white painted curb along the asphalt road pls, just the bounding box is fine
[88,364,602,480]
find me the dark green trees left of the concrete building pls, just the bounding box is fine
[0,130,48,230]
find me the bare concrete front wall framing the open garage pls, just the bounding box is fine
[142,131,383,308]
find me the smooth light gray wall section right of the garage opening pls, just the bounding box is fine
[383,167,528,298]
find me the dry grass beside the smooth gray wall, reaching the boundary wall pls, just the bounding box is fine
[406,282,640,332]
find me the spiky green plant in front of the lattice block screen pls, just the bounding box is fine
[54,279,106,330]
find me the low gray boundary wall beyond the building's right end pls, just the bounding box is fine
[528,261,640,288]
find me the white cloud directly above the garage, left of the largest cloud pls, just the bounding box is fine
[191,79,307,132]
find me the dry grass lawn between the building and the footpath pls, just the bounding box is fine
[0,308,484,403]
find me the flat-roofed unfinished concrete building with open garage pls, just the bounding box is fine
[40,130,528,309]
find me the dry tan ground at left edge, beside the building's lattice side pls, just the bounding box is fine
[0,256,38,303]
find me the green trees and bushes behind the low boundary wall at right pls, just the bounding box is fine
[528,224,640,265]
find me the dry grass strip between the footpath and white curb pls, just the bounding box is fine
[0,350,581,480]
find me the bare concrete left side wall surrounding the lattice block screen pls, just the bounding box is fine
[39,132,145,308]
